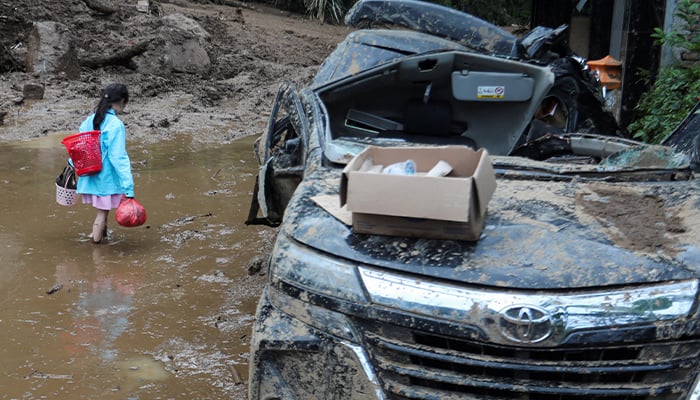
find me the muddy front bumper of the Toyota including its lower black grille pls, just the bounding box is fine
[250,285,700,400]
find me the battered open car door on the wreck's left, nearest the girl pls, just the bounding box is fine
[246,82,309,226]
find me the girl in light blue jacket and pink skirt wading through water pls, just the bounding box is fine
[76,83,134,243]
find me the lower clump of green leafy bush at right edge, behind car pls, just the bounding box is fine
[627,67,700,143]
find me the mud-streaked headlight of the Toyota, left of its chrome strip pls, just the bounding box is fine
[270,233,367,304]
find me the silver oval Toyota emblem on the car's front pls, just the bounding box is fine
[499,305,552,344]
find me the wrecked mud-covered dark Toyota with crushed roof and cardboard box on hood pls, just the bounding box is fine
[248,0,700,400]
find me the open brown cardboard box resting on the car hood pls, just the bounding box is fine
[340,146,496,241]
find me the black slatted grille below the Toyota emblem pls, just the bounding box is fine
[361,323,700,400]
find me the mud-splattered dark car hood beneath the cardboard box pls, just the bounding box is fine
[283,160,700,290]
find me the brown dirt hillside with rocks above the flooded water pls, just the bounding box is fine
[0,0,349,142]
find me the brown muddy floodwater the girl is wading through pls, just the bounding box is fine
[0,135,269,399]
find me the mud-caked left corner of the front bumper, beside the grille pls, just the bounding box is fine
[249,287,385,400]
